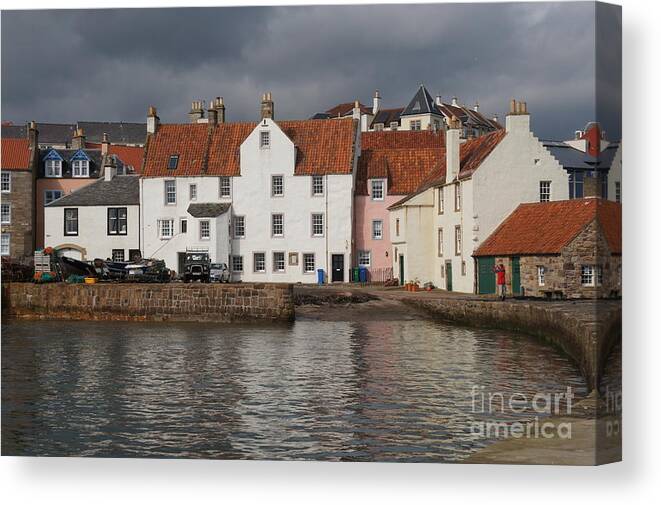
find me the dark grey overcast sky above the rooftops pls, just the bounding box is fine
[2,2,621,138]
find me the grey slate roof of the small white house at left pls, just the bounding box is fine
[46,175,140,207]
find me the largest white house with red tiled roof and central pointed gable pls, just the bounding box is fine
[140,94,360,283]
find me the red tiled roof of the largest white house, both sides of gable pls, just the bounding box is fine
[143,119,357,177]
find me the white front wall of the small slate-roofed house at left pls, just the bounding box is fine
[44,205,140,260]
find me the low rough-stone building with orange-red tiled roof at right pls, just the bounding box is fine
[474,197,622,298]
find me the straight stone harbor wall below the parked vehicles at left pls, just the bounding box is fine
[2,283,294,322]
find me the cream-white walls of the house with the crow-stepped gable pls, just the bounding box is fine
[391,115,569,293]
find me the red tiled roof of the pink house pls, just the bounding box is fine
[356,148,445,195]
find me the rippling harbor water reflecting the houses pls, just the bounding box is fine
[2,320,585,461]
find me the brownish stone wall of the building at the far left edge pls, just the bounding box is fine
[2,170,34,263]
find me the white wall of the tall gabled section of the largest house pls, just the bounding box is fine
[232,119,355,283]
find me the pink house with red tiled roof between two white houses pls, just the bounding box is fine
[354,131,445,282]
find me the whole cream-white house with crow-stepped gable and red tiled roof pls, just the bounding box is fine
[390,102,569,293]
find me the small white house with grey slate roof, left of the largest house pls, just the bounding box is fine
[44,165,141,261]
